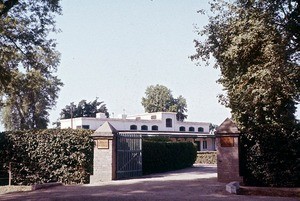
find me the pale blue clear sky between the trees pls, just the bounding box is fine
[42,0,298,127]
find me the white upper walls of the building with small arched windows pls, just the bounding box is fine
[60,112,210,134]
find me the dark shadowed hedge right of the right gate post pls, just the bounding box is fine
[241,125,300,187]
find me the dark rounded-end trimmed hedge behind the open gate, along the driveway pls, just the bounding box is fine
[142,141,197,174]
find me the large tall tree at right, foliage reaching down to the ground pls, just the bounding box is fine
[191,0,300,186]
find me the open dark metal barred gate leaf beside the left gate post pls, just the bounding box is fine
[117,133,143,179]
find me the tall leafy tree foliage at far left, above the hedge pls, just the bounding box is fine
[0,0,62,130]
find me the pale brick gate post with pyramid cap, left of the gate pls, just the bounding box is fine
[90,122,117,183]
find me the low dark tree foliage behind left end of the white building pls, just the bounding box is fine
[60,98,109,119]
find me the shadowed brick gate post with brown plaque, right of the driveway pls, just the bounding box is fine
[216,118,243,182]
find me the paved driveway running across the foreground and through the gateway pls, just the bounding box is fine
[0,165,299,201]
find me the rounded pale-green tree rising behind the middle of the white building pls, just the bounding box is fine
[142,84,187,121]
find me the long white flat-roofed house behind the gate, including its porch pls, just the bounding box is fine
[60,112,215,151]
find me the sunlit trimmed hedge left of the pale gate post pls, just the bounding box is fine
[0,129,93,185]
